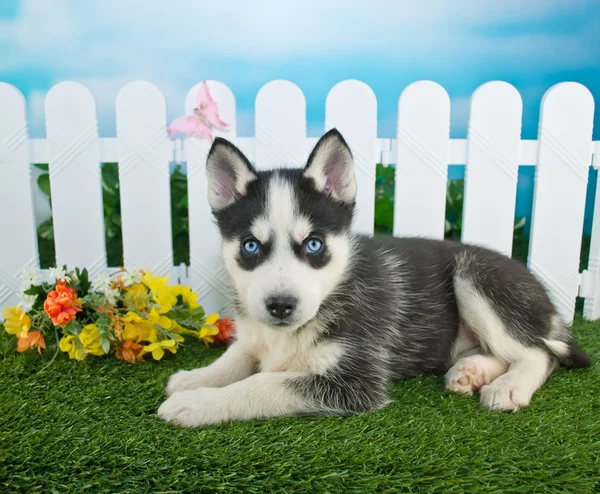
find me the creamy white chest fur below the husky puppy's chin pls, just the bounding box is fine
[237,319,344,374]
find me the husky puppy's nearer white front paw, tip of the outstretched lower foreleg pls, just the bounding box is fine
[158,388,230,427]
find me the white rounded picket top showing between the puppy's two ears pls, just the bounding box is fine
[255,81,306,170]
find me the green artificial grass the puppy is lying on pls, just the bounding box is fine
[0,319,600,493]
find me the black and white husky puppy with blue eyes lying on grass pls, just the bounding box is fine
[158,130,590,427]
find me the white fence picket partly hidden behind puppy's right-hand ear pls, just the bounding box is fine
[325,80,379,235]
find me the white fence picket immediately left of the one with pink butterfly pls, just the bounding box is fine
[117,81,173,276]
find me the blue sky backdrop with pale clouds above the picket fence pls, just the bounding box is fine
[0,0,600,233]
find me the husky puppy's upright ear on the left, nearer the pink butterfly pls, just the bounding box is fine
[206,137,257,211]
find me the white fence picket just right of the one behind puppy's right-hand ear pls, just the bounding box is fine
[394,81,450,239]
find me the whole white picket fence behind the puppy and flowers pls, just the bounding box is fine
[0,80,600,322]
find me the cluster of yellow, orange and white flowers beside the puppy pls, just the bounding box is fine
[3,266,235,364]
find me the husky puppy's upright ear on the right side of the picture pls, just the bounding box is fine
[303,129,356,204]
